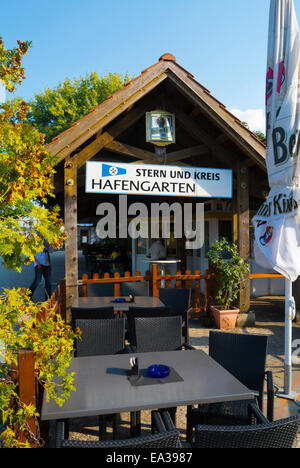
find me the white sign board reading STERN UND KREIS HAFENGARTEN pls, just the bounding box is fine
[85,161,232,198]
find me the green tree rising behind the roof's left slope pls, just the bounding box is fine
[29,72,129,143]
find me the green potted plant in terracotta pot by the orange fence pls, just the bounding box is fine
[208,239,249,329]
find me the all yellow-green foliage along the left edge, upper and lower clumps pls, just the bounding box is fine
[0,38,75,447]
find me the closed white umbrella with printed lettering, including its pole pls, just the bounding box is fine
[253,0,300,401]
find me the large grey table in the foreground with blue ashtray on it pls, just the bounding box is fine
[41,350,253,421]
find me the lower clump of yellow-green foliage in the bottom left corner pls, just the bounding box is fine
[0,289,79,447]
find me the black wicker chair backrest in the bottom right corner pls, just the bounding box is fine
[194,416,300,448]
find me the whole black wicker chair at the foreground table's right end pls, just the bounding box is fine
[187,331,274,441]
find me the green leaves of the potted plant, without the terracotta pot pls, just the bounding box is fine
[207,239,249,310]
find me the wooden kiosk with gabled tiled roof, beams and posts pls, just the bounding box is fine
[47,54,268,318]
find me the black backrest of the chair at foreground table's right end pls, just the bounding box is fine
[209,331,268,394]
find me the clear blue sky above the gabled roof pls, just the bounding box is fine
[0,0,300,129]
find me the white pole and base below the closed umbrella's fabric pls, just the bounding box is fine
[276,279,300,406]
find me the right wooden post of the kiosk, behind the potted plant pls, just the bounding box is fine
[237,164,250,312]
